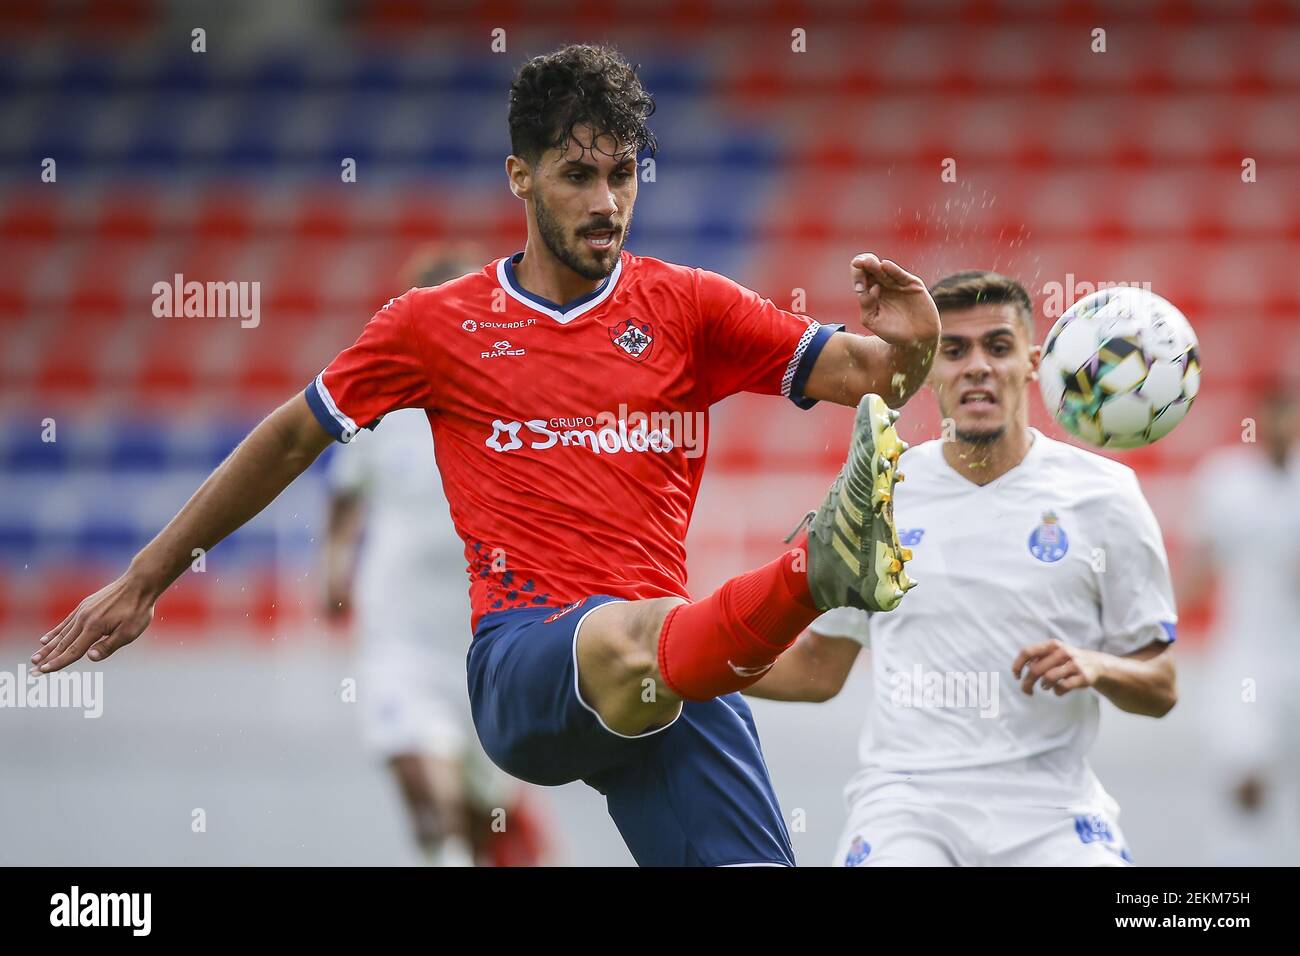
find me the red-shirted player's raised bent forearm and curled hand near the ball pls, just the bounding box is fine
[805,252,939,407]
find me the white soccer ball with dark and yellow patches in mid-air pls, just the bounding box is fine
[1039,287,1201,449]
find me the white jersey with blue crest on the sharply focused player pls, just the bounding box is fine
[814,429,1177,803]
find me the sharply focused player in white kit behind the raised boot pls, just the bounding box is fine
[749,271,1177,866]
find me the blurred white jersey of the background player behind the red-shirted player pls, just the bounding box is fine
[329,408,471,647]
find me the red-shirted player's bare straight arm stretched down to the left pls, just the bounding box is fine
[31,394,333,671]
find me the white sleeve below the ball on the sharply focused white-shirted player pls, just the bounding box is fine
[1097,472,1178,656]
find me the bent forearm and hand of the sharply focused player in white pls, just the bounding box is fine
[1011,641,1178,717]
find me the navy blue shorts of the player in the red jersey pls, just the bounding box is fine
[468,596,794,866]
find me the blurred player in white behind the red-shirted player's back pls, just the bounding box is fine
[324,247,542,866]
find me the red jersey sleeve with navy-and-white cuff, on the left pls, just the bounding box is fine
[304,289,436,442]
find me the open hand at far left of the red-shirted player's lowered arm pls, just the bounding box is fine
[31,572,157,672]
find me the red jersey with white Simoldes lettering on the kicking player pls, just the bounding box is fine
[306,251,840,627]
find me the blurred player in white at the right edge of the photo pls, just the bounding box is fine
[1179,384,1300,862]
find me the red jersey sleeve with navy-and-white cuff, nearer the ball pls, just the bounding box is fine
[694,269,844,408]
